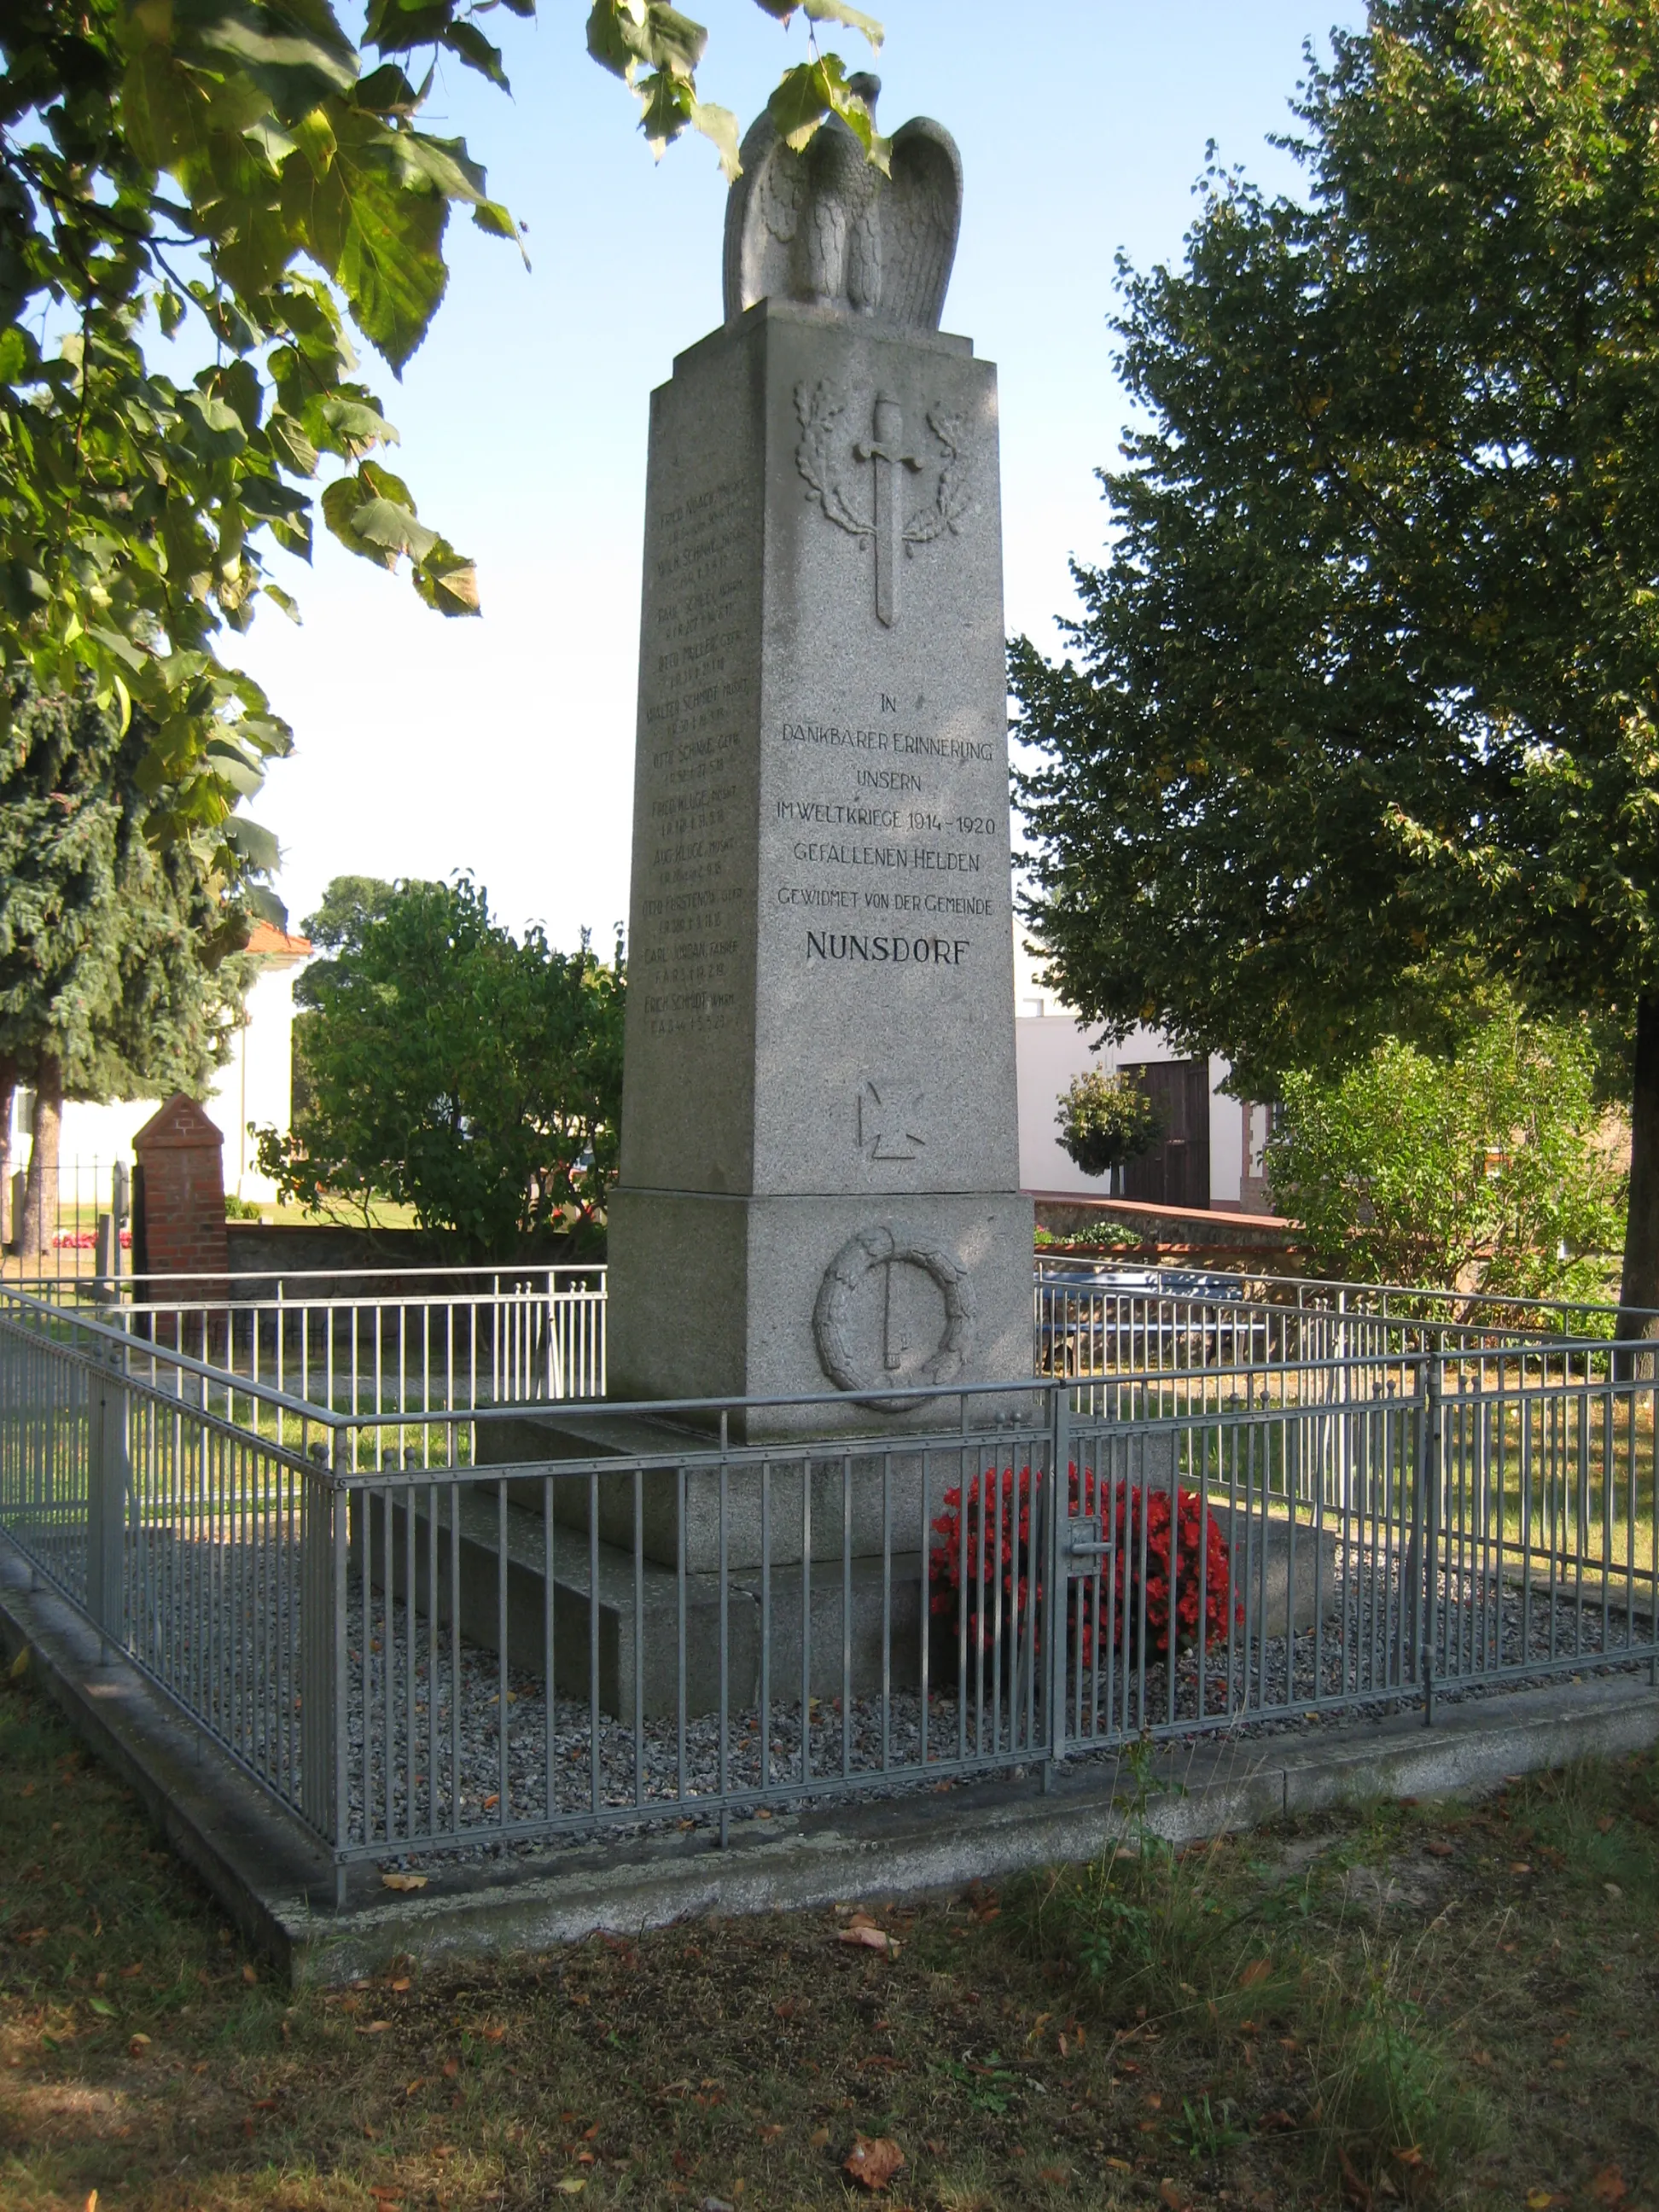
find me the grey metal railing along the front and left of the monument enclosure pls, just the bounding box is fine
[0,1299,1659,1883]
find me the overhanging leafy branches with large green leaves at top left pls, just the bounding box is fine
[0,0,885,867]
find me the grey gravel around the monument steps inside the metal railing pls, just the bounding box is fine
[58,1544,1648,1867]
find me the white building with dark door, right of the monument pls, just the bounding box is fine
[1013,923,1267,1212]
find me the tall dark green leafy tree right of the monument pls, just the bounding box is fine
[1013,0,1659,1334]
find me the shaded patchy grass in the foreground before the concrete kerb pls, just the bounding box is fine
[0,1679,1659,2212]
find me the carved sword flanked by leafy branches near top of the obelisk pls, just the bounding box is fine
[795,382,973,631]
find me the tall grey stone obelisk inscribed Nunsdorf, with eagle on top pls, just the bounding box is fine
[608,79,1031,1435]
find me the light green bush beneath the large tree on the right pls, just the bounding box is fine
[1267,1004,1624,1299]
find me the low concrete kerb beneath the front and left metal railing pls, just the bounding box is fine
[0,1537,1659,1982]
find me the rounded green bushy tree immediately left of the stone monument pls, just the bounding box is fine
[259,876,624,1259]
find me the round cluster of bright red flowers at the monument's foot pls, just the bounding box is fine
[927,1464,1243,1666]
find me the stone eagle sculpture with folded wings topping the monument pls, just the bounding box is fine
[725,75,963,329]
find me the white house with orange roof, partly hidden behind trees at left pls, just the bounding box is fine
[11,923,311,1210]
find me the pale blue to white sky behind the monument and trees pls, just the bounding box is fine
[236,0,1363,949]
